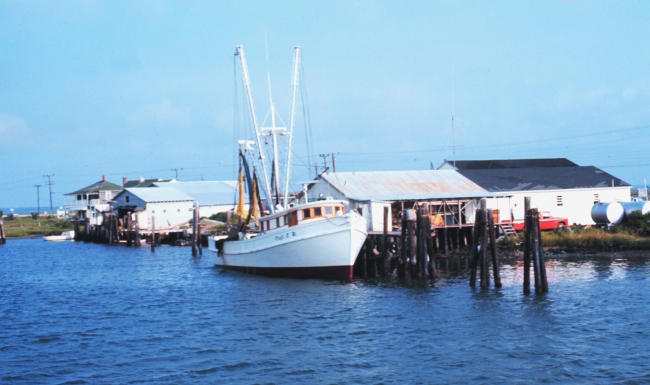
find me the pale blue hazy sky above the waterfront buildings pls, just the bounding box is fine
[0,1,650,207]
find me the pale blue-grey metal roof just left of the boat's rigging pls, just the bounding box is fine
[153,181,248,206]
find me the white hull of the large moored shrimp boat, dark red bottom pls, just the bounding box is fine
[209,213,367,279]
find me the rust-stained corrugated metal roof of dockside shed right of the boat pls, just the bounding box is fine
[321,170,495,201]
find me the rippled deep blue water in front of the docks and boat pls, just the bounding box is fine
[0,239,650,384]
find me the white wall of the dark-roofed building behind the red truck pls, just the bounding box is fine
[487,187,630,225]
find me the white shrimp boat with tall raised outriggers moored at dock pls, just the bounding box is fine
[208,46,368,280]
